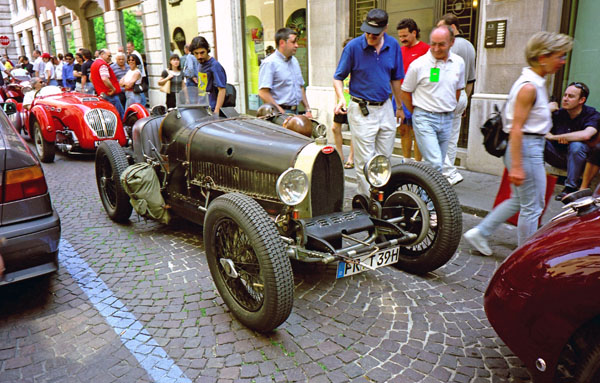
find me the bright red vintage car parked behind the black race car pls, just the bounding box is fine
[9,86,149,162]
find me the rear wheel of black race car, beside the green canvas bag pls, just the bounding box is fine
[96,141,133,222]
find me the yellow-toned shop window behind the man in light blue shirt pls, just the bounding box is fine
[243,0,309,111]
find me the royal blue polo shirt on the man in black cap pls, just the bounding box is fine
[332,33,404,102]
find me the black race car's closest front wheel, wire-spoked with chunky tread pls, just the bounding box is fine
[204,193,294,332]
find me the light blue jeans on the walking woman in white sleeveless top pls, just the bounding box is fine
[477,136,546,246]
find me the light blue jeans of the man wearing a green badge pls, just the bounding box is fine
[412,107,454,173]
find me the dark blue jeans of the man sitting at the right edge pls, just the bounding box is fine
[544,140,590,189]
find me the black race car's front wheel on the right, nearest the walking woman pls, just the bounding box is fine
[383,162,462,274]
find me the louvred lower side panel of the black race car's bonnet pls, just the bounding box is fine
[191,161,279,201]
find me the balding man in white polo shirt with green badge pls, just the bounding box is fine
[402,26,465,173]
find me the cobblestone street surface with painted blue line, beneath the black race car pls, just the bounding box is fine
[0,155,530,383]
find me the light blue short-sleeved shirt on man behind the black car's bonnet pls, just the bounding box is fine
[258,50,304,106]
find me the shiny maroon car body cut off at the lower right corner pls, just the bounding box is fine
[484,189,600,382]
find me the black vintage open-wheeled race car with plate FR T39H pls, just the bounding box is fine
[96,94,462,332]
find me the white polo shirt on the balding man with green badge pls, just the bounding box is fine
[402,51,465,113]
